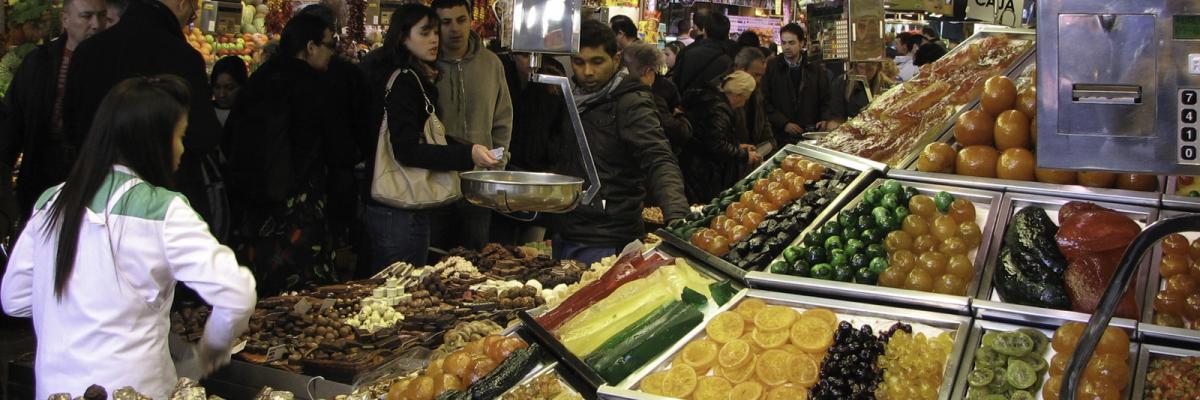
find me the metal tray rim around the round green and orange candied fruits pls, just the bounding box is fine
[746,176,1002,315]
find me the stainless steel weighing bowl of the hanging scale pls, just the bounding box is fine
[458,171,583,213]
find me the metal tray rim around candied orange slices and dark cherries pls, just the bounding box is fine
[599,289,971,400]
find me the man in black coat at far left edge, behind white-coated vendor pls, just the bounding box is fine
[0,0,108,220]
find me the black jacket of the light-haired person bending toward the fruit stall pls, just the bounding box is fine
[680,83,749,203]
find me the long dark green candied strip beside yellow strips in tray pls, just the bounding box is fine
[587,288,708,384]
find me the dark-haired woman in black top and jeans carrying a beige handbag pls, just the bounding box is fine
[364,4,499,268]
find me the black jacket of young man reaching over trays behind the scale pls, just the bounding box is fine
[554,78,688,249]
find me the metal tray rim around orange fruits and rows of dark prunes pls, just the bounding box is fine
[655,143,887,283]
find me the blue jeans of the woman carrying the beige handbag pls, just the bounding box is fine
[362,203,430,270]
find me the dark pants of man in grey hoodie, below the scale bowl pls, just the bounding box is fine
[430,199,492,251]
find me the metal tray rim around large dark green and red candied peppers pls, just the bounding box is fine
[971,193,1158,328]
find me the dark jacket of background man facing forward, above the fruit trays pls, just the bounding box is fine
[762,56,835,145]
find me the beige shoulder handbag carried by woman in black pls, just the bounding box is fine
[371,70,462,209]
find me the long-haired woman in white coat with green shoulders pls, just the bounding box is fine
[0,76,256,399]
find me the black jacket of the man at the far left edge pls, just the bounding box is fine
[0,35,74,215]
